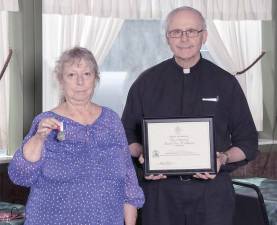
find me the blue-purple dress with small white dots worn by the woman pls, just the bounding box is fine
[9,107,144,225]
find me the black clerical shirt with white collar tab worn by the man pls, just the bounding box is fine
[122,58,258,170]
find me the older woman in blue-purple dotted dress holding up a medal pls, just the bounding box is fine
[9,47,144,225]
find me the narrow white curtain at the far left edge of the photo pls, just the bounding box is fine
[0,12,9,155]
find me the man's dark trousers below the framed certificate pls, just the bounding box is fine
[141,173,235,225]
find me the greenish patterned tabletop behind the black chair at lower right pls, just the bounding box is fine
[234,177,277,225]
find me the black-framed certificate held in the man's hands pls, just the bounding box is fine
[143,117,216,175]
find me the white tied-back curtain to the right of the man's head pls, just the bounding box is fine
[206,21,263,131]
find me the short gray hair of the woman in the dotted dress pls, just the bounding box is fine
[54,47,100,103]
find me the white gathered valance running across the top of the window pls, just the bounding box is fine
[43,0,272,20]
